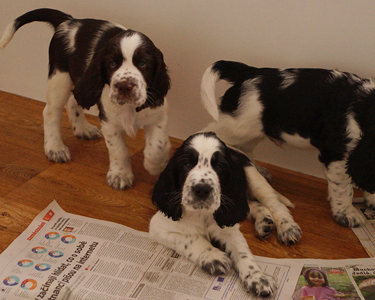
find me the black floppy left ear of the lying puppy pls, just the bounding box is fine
[151,154,182,221]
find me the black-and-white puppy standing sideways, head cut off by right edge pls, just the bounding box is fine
[201,61,375,227]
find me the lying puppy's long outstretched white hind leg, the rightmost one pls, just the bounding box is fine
[245,166,302,245]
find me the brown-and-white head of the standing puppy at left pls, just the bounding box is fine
[73,27,170,111]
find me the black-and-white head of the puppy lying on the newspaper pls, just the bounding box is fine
[152,133,250,227]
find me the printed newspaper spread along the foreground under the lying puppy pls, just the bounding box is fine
[0,201,375,300]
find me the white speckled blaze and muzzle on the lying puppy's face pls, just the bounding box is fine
[182,135,221,213]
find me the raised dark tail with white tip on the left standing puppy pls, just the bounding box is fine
[0,8,73,48]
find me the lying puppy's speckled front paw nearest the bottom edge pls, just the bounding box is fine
[241,271,277,297]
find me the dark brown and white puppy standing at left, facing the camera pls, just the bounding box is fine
[0,9,170,189]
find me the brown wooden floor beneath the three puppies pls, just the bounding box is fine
[0,92,368,259]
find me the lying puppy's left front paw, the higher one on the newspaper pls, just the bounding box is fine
[199,248,232,276]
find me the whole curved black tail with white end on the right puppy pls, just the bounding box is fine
[201,60,259,121]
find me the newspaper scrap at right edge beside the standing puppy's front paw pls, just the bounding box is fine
[353,198,375,257]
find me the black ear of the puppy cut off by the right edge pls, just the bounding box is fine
[347,129,375,194]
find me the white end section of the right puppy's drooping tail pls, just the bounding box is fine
[201,63,220,121]
